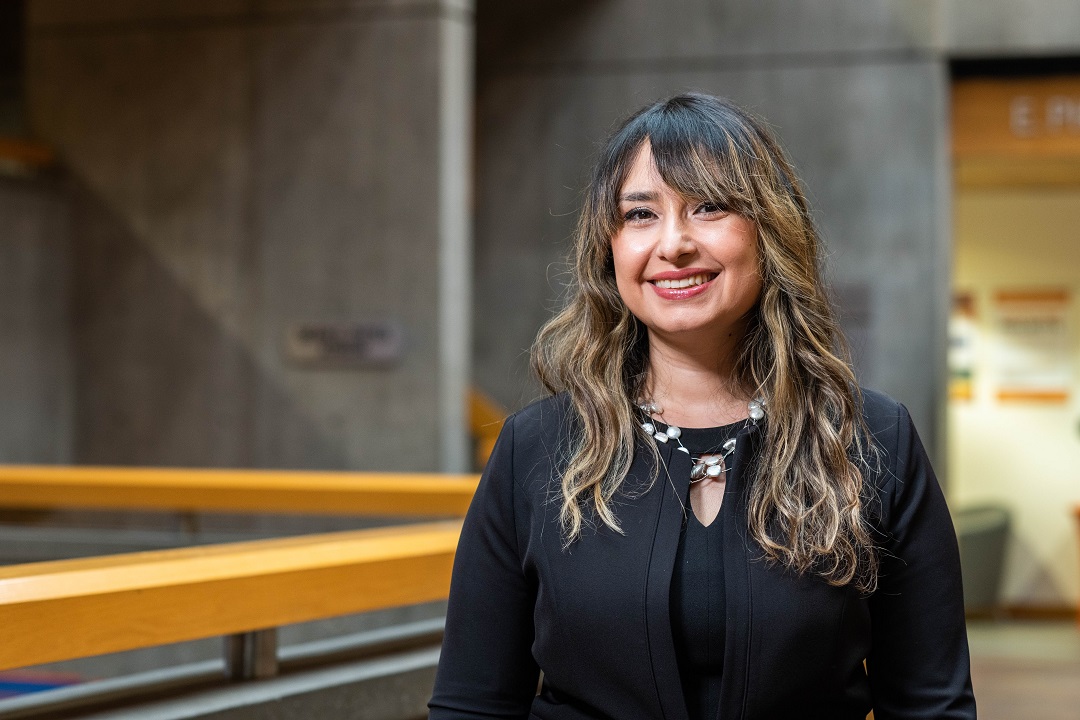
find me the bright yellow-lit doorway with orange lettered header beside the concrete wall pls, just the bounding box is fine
[947,63,1080,615]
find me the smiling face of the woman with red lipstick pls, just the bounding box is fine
[611,141,761,350]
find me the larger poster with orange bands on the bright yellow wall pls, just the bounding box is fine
[995,289,1072,404]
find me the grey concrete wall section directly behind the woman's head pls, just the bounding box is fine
[475,0,949,455]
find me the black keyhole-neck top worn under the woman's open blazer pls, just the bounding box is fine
[671,421,744,720]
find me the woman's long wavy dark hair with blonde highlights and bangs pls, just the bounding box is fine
[531,94,877,592]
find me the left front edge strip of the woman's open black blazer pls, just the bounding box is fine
[645,443,691,720]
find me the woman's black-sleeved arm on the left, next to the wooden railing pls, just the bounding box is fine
[428,418,540,720]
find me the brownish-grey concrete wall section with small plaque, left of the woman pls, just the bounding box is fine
[26,0,472,471]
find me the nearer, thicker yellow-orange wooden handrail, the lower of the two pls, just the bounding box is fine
[0,521,460,669]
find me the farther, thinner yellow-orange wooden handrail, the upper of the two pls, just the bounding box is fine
[0,465,478,517]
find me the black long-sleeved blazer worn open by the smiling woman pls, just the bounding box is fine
[429,392,975,720]
